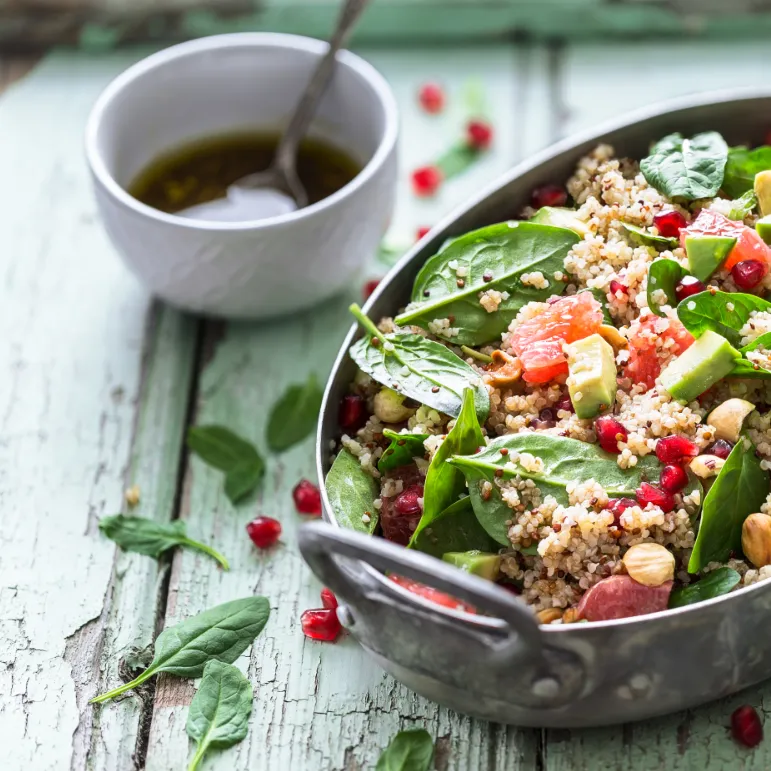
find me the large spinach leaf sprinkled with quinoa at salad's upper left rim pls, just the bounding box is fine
[396,222,580,346]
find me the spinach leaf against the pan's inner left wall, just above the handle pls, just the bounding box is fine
[324,448,380,535]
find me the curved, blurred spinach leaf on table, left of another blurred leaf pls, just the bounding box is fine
[187,426,265,504]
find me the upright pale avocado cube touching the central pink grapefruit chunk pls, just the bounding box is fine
[565,334,616,419]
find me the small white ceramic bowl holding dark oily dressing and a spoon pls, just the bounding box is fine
[86,33,398,318]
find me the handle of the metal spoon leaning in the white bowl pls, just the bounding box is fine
[275,0,369,169]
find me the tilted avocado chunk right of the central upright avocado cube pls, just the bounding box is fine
[661,330,741,403]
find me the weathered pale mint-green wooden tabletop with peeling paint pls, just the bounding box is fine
[6,37,771,771]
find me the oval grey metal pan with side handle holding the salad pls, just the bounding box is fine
[300,90,771,727]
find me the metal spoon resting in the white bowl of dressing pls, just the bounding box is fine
[182,0,369,222]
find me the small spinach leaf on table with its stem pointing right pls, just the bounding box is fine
[99,514,230,570]
